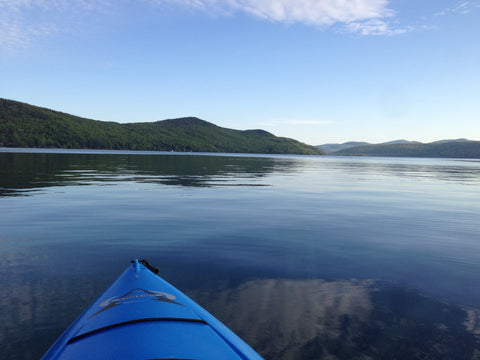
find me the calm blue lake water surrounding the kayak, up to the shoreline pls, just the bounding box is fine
[0,149,480,359]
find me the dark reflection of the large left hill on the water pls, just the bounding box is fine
[0,153,298,196]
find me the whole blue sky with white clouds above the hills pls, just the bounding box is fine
[0,0,480,145]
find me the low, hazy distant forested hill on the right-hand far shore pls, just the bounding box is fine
[332,140,480,159]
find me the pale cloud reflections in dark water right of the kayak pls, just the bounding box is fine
[192,279,480,359]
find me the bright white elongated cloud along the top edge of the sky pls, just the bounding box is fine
[162,0,406,35]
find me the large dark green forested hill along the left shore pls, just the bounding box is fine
[0,99,323,155]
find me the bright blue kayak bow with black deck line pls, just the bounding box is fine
[43,260,262,360]
